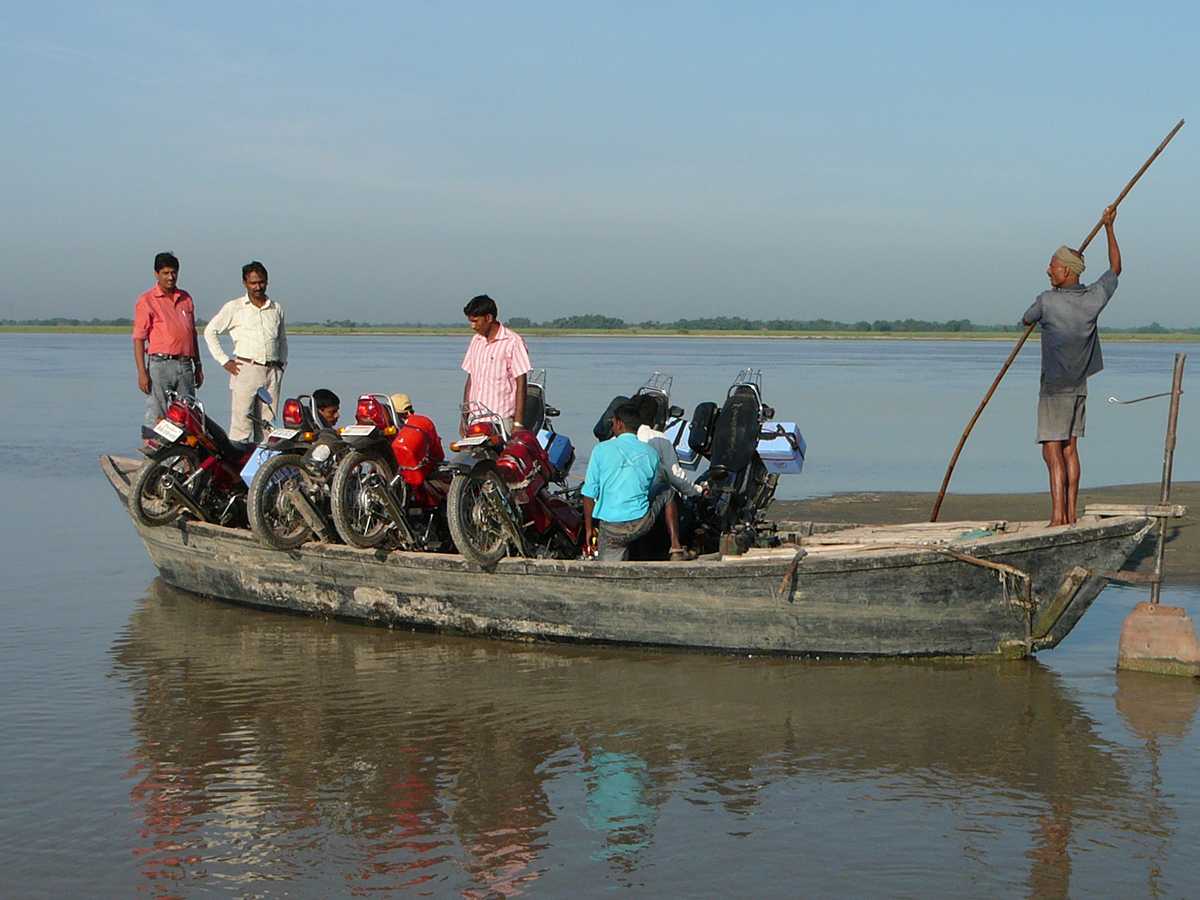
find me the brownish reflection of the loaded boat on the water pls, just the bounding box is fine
[113,583,1195,895]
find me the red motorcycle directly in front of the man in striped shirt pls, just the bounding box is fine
[446,371,583,568]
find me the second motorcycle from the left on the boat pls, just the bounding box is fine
[241,394,348,550]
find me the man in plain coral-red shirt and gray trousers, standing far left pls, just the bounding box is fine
[133,252,204,437]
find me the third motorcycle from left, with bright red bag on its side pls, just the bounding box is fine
[331,394,450,551]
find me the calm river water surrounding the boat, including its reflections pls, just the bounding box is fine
[0,335,1200,898]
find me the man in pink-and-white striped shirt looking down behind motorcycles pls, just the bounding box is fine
[458,294,530,433]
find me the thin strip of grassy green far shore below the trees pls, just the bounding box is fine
[0,325,1200,343]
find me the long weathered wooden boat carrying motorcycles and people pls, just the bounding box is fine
[101,456,1153,656]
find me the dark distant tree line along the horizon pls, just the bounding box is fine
[0,313,1200,335]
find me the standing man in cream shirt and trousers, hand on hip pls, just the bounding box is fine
[204,260,288,443]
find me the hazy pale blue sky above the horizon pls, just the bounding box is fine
[0,2,1200,325]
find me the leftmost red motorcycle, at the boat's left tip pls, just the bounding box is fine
[130,390,274,528]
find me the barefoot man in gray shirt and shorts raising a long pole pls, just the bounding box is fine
[1022,206,1121,526]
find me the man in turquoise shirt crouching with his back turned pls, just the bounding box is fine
[582,403,684,562]
